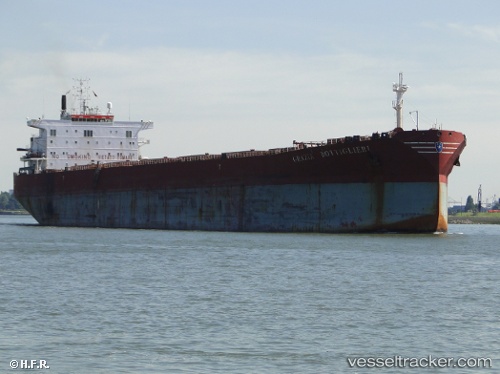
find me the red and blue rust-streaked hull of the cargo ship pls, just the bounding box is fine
[14,131,465,233]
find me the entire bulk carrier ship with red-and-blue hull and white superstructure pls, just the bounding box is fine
[14,73,466,233]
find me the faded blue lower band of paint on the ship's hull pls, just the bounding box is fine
[31,182,440,232]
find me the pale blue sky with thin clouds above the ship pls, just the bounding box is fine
[0,0,500,204]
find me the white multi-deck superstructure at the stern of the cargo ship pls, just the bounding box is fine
[18,79,153,173]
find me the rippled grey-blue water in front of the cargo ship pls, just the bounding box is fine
[0,216,500,373]
